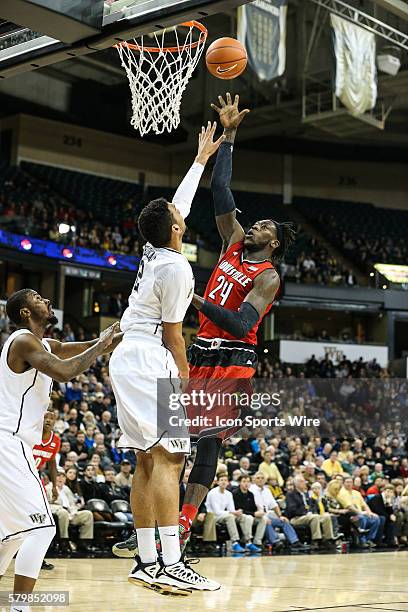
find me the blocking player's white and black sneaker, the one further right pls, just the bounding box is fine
[154,559,221,595]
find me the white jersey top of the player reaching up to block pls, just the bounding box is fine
[120,243,194,334]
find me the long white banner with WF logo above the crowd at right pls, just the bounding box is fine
[279,340,388,368]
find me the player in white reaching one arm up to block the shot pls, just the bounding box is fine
[109,124,223,595]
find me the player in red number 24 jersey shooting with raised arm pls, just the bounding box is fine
[180,94,296,546]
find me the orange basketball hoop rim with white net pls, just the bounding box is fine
[115,21,208,136]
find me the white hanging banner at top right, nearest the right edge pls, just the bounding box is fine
[330,14,377,115]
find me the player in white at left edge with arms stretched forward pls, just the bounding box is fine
[0,289,122,612]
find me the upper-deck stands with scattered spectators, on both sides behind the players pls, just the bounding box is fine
[0,162,408,287]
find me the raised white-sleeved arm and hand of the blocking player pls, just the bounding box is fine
[173,122,225,219]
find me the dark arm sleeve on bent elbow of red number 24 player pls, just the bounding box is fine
[200,300,259,339]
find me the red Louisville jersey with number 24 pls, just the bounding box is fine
[197,240,275,345]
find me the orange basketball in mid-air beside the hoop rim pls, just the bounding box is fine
[205,37,248,80]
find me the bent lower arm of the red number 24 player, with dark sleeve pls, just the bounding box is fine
[193,270,280,340]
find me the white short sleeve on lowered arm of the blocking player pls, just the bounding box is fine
[160,265,194,323]
